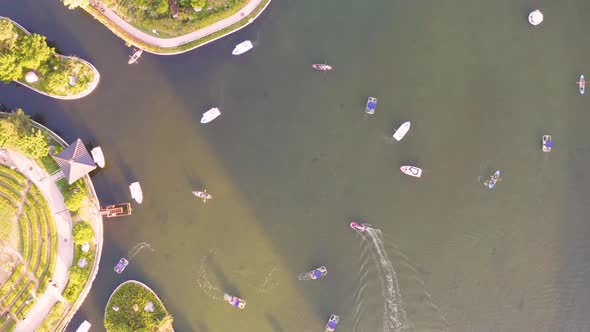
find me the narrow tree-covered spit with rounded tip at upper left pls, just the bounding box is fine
[0,17,100,99]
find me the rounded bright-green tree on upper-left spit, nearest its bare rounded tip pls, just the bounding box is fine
[15,33,55,69]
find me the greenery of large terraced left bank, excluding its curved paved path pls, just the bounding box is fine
[0,110,102,331]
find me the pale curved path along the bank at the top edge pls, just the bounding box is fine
[91,0,262,48]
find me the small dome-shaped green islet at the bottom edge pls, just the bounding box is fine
[104,280,174,332]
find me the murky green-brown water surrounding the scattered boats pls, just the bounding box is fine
[0,0,590,332]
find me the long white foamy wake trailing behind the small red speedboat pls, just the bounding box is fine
[365,227,408,332]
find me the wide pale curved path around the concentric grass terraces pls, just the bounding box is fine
[0,149,74,332]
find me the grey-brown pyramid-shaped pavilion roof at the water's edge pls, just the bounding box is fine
[53,138,96,184]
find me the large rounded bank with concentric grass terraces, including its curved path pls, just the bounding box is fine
[0,109,102,332]
